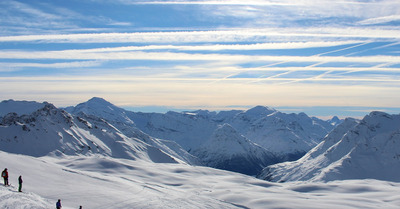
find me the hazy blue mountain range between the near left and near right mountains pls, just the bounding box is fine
[65,97,335,175]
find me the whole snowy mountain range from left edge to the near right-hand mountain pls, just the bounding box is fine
[0,97,335,175]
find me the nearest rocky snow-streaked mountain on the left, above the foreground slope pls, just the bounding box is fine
[0,103,197,163]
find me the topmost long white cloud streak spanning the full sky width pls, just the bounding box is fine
[0,28,400,43]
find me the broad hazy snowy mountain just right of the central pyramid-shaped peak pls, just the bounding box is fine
[229,106,334,160]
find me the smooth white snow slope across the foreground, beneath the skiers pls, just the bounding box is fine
[0,152,400,209]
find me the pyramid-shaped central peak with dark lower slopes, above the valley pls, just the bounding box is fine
[193,124,278,175]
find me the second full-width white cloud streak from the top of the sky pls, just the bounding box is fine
[0,49,400,64]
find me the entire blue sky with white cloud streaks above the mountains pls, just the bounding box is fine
[0,0,400,118]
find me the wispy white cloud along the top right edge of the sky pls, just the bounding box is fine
[126,0,400,25]
